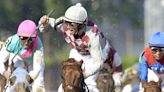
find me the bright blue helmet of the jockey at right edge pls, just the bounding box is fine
[149,32,164,47]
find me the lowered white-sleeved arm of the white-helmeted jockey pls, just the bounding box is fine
[84,34,104,76]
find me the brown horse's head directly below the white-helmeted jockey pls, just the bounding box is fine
[62,58,86,92]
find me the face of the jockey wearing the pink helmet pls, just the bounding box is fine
[19,36,36,48]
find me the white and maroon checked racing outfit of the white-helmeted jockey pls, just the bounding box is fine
[39,18,121,92]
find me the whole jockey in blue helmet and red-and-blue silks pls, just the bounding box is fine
[139,32,164,92]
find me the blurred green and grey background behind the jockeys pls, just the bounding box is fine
[0,0,164,92]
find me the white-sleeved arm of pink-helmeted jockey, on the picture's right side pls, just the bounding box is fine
[29,48,45,80]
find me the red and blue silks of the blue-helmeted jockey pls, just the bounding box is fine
[139,47,164,81]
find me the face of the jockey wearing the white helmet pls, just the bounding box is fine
[64,21,79,35]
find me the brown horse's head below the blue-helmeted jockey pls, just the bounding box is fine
[144,79,162,92]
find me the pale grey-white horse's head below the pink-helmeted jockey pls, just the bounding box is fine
[5,67,33,92]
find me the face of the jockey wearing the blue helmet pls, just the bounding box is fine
[150,47,164,60]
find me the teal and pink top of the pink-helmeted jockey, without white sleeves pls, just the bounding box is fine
[5,34,42,62]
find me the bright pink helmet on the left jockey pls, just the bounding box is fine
[17,19,37,37]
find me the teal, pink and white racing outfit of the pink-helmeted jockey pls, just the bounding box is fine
[0,34,45,87]
